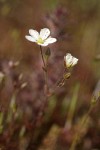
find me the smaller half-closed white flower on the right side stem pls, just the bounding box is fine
[64,53,78,68]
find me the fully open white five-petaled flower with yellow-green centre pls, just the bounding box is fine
[25,28,57,46]
